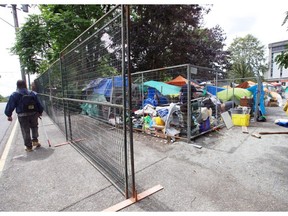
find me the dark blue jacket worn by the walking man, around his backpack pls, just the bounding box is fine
[5,89,43,117]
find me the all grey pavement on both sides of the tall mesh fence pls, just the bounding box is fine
[0,107,288,212]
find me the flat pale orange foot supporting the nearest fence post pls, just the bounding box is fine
[103,185,163,212]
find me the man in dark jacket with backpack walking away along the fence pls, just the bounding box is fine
[5,80,43,152]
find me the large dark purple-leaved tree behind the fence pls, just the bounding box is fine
[131,5,227,75]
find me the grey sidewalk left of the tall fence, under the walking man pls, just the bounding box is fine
[0,115,123,211]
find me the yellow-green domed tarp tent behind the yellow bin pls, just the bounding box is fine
[217,88,252,102]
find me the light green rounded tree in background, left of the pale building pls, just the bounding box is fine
[228,34,268,81]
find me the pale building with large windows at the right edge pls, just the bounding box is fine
[264,40,288,86]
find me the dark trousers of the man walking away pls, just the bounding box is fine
[18,113,39,148]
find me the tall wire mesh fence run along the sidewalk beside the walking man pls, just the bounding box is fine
[35,6,136,197]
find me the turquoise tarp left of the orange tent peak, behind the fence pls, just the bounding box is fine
[144,80,181,95]
